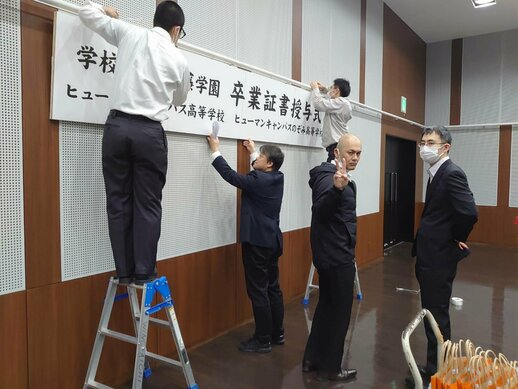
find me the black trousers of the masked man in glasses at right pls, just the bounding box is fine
[415,263,457,373]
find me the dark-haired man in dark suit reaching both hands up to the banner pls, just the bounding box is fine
[207,136,284,353]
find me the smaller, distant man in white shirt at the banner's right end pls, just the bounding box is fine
[309,78,352,162]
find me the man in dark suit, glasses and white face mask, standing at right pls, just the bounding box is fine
[406,126,477,387]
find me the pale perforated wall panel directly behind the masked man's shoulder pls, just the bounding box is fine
[450,128,500,206]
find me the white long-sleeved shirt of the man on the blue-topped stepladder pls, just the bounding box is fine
[79,2,191,121]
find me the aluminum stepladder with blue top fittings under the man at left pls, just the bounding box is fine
[83,276,198,389]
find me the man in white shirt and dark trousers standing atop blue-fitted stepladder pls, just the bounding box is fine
[79,1,190,284]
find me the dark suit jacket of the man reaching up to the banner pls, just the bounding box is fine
[212,156,284,255]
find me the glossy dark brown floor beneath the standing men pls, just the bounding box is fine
[119,244,518,389]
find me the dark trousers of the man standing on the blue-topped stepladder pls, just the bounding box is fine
[102,111,167,277]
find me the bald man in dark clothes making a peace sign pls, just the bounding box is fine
[302,134,362,381]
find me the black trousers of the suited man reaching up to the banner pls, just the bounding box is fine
[241,242,284,343]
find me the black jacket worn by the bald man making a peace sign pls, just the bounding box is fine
[309,162,356,270]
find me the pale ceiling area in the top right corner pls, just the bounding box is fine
[384,0,518,43]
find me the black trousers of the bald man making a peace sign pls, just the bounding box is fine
[304,264,356,373]
